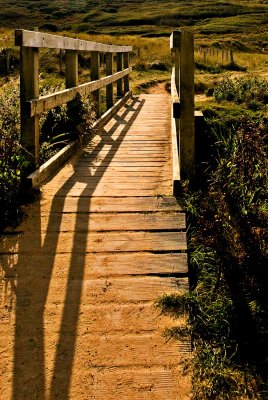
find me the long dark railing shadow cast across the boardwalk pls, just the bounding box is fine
[7,98,144,400]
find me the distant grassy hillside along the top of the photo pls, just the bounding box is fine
[0,0,268,47]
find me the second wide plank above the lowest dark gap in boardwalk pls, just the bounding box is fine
[0,231,187,254]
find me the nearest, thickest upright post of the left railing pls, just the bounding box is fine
[20,47,39,168]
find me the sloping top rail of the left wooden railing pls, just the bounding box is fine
[15,29,132,53]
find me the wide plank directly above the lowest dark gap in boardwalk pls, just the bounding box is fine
[1,252,188,279]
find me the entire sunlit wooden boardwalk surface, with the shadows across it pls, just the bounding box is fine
[0,94,190,400]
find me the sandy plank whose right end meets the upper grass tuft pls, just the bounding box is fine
[12,278,189,304]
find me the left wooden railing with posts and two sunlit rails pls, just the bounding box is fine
[15,30,132,167]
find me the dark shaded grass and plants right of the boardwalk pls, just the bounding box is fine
[157,78,268,400]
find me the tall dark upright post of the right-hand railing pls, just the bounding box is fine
[180,30,195,179]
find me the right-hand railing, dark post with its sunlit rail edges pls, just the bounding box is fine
[170,29,195,186]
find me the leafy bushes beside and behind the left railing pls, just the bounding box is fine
[0,79,94,232]
